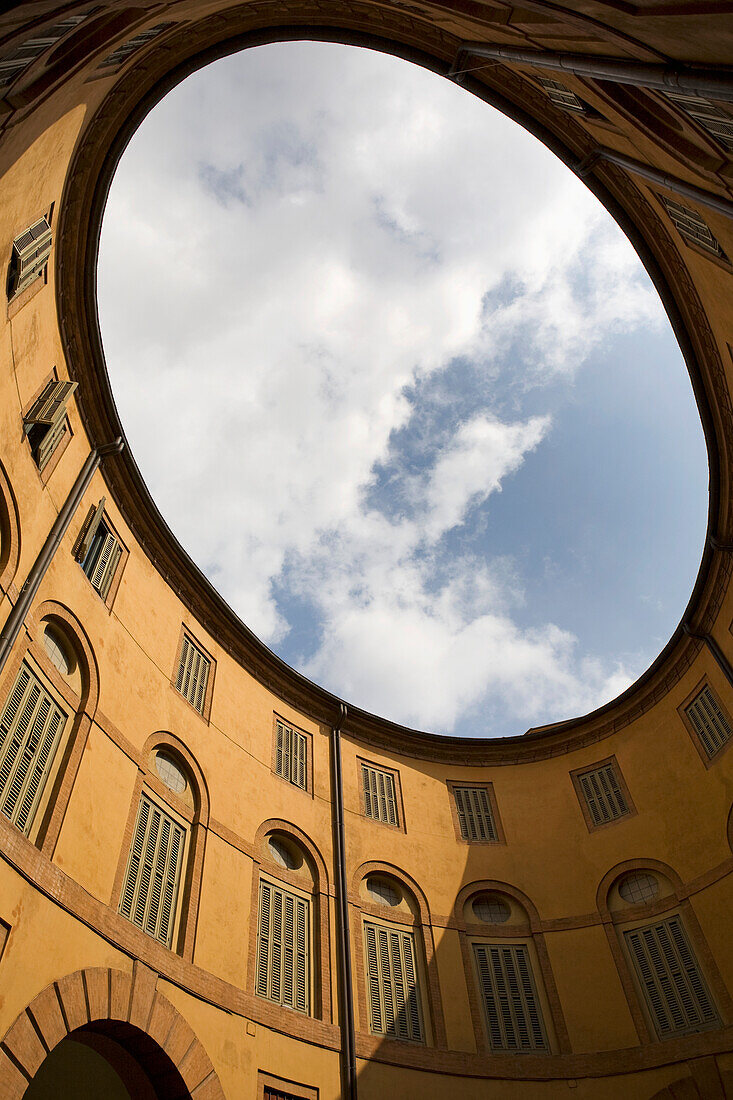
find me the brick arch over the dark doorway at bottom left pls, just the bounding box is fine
[0,963,226,1100]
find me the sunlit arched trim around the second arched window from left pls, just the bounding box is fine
[109,730,209,963]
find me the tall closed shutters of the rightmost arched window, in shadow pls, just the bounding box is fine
[624,916,720,1038]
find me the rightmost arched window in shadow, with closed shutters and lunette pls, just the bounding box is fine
[608,866,721,1040]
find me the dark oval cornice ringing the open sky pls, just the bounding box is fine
[56,0,733,766]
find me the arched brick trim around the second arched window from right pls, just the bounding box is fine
[451,879,571,1055]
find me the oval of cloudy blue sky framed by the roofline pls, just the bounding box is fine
[94,43,707,736]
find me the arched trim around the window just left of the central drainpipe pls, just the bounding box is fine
[247,817,335,1025]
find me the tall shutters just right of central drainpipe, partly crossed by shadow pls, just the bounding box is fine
[364,922,425,1043]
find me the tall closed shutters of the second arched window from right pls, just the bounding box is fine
[473,944,549,1052]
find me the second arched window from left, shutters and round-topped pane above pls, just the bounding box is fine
[118,735,204,955]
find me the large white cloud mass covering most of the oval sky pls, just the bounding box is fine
[100,44,663,732]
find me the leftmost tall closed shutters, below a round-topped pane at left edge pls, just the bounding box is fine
[0,664,66,835]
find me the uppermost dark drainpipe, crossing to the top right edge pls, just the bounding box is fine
[448,42,733,102]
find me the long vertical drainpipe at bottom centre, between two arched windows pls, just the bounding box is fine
[331,703,357,1100]
